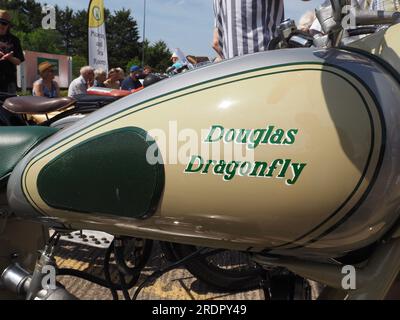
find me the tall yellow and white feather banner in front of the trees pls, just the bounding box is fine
[88,0,108,71]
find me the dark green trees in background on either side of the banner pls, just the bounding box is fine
[0,0,171,75]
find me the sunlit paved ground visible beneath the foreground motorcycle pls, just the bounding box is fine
[56,240,264,300]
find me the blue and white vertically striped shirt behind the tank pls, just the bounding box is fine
[214,0,284,59]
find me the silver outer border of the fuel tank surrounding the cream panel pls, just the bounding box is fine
[8,49,400,258]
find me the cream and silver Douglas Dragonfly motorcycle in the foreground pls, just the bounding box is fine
[0,0,400,299]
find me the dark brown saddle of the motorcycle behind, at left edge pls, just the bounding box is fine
[3,96,75,114]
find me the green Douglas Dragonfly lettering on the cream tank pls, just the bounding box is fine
[184,126,307,186]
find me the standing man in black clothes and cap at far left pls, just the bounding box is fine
[0,9,24,93]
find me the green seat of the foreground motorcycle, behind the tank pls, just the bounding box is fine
[0,126,58,181]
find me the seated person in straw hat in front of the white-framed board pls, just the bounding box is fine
[32,61,60,98]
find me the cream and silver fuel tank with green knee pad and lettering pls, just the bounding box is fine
[8,25,400,256]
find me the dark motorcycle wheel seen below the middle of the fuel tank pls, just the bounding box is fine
[161,242,261,292]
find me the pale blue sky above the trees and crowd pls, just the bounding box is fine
[39,0,322,57]
